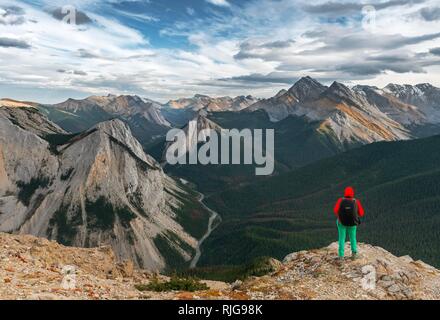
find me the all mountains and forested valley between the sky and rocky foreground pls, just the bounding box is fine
[0,77,440,270]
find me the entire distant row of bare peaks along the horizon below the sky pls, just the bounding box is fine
[18,77,440,159]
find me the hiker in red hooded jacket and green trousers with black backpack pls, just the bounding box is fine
[333,187,365,259]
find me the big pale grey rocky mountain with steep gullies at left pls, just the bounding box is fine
[0,107,209,270]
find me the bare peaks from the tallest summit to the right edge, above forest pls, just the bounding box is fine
[245,77,440,145]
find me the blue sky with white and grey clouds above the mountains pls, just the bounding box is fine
[0,0,440,103]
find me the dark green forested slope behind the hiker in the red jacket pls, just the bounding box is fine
[200,136,440,265]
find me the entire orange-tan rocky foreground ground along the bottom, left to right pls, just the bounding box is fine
[0,233,440,300]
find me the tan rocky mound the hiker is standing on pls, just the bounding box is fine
[240,243,440,300]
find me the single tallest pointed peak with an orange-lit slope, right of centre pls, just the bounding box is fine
[246,77,411,145]
